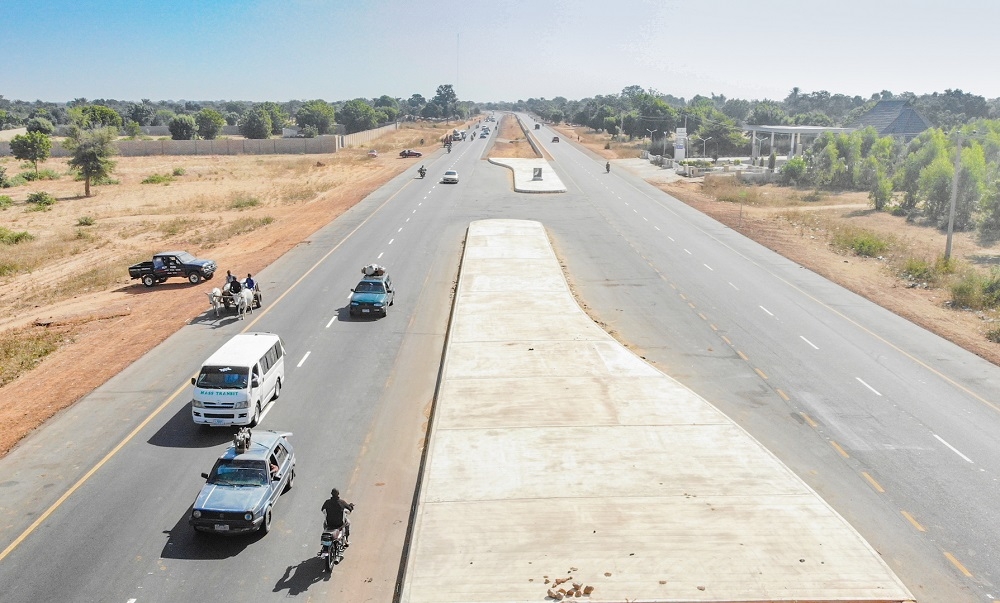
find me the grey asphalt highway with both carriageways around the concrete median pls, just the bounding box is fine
[0,114,1000,603]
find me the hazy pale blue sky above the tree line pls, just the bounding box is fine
[7,0,1000,101]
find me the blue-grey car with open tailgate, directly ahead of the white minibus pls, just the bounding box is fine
[188,428,295,534]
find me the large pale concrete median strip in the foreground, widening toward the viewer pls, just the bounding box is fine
[401,220,913,603]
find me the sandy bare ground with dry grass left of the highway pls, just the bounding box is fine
[0,119,474,454]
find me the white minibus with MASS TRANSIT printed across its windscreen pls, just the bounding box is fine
[191,333,285,427]
